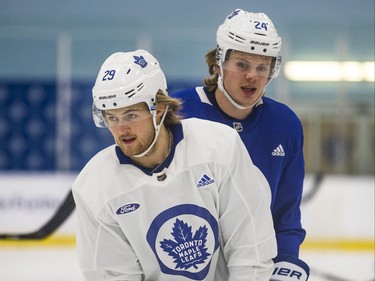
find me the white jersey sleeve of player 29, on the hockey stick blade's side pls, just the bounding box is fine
[73,189,143,281]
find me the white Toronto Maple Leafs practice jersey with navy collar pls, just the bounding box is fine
[73,119,276,281]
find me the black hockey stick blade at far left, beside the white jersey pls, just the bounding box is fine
[0,190,75,240]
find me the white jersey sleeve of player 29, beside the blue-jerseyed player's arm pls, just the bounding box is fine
[219,134,276,281]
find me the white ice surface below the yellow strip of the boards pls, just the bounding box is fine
[0,242,374,281]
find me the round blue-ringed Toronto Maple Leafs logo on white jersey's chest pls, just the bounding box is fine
[146,204,219,280]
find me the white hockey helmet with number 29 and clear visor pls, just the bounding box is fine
[92,50,167,128]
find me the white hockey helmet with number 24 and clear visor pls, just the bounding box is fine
[216,9,281,79]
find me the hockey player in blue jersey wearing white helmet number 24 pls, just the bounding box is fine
[171,9,309,281]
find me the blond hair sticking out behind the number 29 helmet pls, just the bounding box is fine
[156,90,182,128]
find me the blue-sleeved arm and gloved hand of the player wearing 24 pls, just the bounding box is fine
[271,116,310,280]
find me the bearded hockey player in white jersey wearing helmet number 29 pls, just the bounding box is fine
[72,50,276,281]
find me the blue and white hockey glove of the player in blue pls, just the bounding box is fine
[270,256,310,281]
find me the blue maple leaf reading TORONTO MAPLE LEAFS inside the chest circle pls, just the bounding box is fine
[160,219,211,269]
